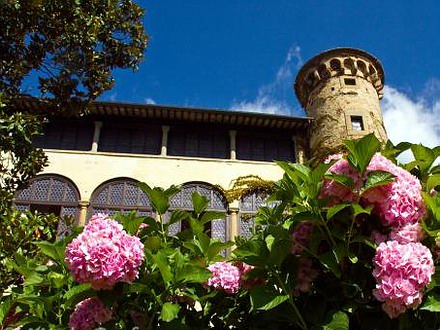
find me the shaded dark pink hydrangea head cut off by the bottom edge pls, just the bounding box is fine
[69,297,112,330]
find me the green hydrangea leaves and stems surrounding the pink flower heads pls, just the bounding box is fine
[4,136,440,330]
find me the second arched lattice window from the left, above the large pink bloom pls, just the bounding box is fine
[89,178,152,218]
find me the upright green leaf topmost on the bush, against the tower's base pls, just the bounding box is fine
[344,134,380,174]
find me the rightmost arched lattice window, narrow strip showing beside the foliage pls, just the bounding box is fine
[238,192,267,238]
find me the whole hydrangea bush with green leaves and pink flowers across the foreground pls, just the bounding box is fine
[0,135,440,329]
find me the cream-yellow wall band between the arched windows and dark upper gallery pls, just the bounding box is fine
[43,150,283,201]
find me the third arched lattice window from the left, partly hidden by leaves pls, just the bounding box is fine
[170,183,229,242]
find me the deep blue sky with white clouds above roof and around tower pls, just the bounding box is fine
[102,0,440,148]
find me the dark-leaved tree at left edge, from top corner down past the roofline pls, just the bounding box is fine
[0,0,148,201]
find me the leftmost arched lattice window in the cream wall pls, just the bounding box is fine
[14,174,80,233]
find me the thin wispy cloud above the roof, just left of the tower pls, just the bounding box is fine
[231,45,304,115]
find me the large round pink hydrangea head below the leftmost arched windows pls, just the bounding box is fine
[66,214,144,289]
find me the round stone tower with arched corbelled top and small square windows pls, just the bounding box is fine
[295,48,388,163]
